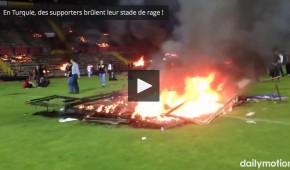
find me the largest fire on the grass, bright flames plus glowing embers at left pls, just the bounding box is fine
[73,73,232,128]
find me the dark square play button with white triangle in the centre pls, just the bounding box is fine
[128,70,159,101]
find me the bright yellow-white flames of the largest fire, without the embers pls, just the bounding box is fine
[132,73,223,119]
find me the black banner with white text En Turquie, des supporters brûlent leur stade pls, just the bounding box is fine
[0,5,169,20]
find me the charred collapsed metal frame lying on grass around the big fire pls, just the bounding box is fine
[26,91,236,129]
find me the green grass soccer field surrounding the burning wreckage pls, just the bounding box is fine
[0,77,290,170]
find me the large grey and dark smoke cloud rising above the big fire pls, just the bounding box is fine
[109,0,290,79]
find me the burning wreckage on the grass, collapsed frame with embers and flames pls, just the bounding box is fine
[27,68,254,128]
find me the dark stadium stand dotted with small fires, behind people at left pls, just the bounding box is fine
[0,18,148,79]
